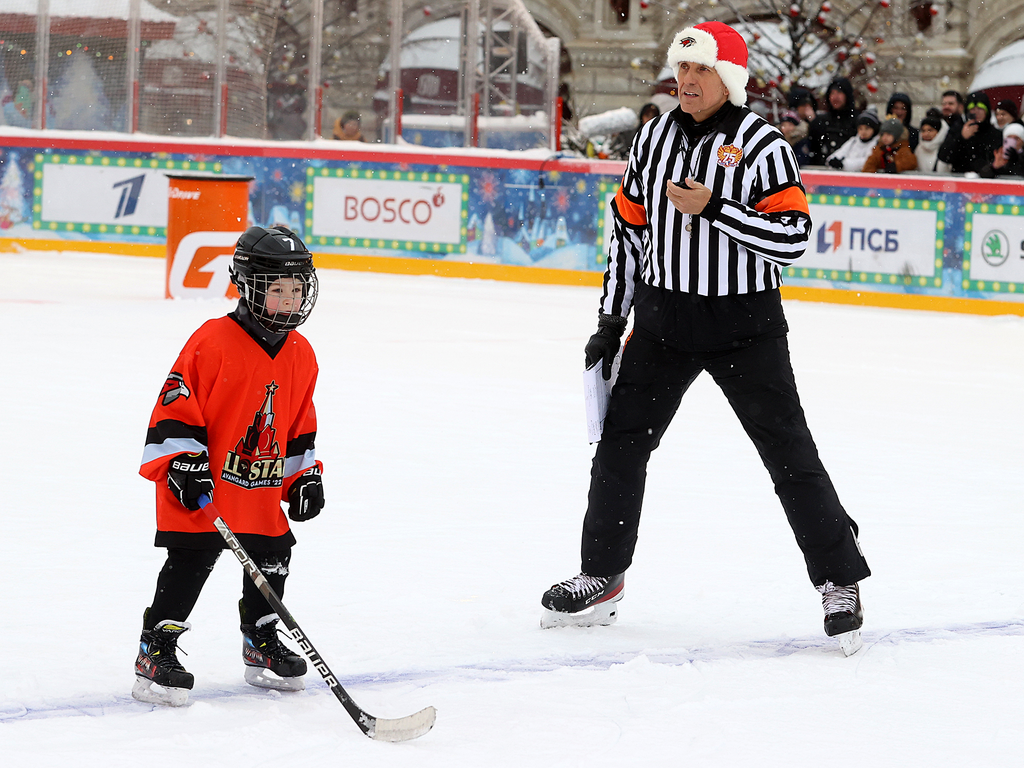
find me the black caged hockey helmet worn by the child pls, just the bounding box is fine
[228,226,317,334]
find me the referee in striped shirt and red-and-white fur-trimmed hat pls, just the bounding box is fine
[542,22,870,655]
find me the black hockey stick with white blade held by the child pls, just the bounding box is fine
[199,494,437,741]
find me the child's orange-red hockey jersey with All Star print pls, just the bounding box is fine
[139,316,318,546]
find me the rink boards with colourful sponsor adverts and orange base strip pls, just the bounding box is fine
[0,131,1024,314]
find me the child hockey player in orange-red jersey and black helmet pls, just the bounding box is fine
[132,226,324,707]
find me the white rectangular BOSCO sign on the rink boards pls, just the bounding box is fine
[312,176,463,244]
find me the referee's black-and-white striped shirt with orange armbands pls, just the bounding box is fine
[601,102,811,317]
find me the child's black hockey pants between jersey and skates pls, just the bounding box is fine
[144,547,292,629]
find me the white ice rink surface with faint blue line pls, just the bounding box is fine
[0,253,1024,768]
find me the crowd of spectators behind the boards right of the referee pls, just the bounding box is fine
[778,77,1024,178]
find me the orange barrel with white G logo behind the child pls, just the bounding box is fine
[164,171,253,299]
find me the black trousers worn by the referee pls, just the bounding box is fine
[583,286,870,585]
